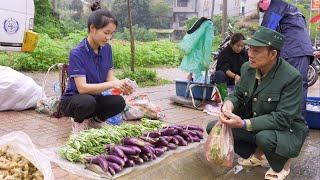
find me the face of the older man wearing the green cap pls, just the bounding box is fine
[248,46,277,69]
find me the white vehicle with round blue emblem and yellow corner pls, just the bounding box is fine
[0,0,38,52]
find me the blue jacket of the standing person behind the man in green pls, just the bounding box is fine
[261,0,313,58]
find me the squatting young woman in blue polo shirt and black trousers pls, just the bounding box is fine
[61,3,132,133]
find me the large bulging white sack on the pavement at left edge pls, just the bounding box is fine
[0,66,45,111]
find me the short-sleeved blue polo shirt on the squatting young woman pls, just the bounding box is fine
[61,38,113,100]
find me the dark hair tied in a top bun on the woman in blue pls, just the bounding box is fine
[87,1,118,32]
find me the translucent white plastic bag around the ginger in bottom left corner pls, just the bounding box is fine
[0,131,54,180]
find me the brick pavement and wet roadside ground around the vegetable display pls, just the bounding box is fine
[0,68,320,180]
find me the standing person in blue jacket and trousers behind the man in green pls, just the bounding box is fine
[258,0,313,119]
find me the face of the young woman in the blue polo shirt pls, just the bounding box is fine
[90,22,117,46]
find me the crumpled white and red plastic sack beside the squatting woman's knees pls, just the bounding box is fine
[124,94,165,120]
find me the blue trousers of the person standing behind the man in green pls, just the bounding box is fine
[285,56,311,119]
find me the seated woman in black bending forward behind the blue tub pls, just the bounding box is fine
[214,33,248,86]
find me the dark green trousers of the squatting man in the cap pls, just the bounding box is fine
[206,121,288,172]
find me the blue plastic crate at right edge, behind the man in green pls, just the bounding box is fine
[306,97,320,129]
